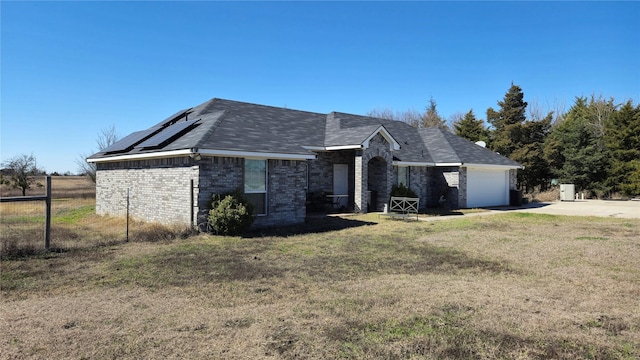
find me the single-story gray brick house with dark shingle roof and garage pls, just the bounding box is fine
[87,98,521,227]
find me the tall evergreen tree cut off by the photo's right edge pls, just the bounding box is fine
[605,100,640,196]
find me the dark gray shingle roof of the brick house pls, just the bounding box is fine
[89,98,519,166]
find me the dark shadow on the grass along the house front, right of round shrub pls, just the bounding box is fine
[242,215,376,238]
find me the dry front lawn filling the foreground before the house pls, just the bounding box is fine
[0,213,640,359]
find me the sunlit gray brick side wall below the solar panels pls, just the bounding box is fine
[96,157,199,225]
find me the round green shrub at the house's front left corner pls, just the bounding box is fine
[208,191,254,235]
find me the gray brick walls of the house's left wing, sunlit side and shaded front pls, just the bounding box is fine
[96,157,307,229]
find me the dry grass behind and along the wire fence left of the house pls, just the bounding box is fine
[0,176,189,259]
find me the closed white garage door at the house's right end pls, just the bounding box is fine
[467,168,509,208]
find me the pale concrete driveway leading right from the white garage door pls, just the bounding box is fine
[504,200,640,219]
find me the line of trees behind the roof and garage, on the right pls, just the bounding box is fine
[368,84,640,198]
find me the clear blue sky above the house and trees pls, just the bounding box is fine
[0,1,640,172]
